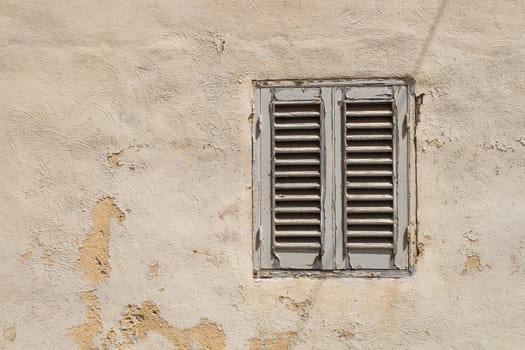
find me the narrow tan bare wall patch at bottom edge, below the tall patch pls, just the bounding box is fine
[69,291,102,350]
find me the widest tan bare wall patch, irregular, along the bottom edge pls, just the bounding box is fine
[103,301,224,350]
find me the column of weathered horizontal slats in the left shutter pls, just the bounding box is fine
[272,102,322,252]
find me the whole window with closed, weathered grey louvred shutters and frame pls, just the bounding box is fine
[253,80,413,277]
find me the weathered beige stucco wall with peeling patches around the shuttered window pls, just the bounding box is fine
[0,0,525,350]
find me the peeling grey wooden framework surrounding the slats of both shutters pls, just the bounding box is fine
[252,79,416,277]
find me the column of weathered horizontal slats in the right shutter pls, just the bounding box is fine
[343,101,395,256]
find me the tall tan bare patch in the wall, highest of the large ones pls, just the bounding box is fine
[76,198,125,287]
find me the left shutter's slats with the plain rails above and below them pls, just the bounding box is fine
[271,89,324,269]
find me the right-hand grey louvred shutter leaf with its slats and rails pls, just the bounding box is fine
[342,87,406,269]
